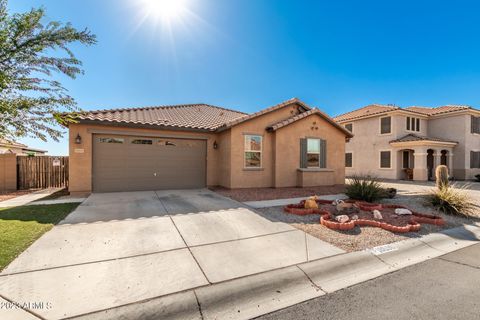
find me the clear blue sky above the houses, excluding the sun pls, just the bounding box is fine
[9,0,480,155]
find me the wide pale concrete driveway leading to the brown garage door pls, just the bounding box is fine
[0,189,342,319]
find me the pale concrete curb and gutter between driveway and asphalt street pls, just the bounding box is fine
[67,225,480,319]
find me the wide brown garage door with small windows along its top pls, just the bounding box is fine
[93,135,206,192]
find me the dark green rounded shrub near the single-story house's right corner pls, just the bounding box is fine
[345,176,386,202]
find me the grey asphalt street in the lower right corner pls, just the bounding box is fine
[256,244,480,320]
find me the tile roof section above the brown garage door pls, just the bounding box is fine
[79,104,246,131]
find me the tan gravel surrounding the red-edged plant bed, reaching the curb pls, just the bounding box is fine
[256,193,480,252]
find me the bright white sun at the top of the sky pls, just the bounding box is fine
[141,0,187,23]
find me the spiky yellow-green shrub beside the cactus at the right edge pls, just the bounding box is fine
[428,185,477,216]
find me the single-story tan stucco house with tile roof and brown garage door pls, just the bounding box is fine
[69,99,352,193]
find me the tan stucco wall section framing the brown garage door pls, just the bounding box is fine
[69,124,219,193]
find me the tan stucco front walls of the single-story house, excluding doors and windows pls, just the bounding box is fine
[69,104,345,193]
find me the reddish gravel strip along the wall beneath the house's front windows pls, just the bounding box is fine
[210,185,345,202]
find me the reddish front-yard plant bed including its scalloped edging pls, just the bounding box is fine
[284,200,445,233]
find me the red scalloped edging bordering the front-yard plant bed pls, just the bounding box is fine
[283,200,445,233]
